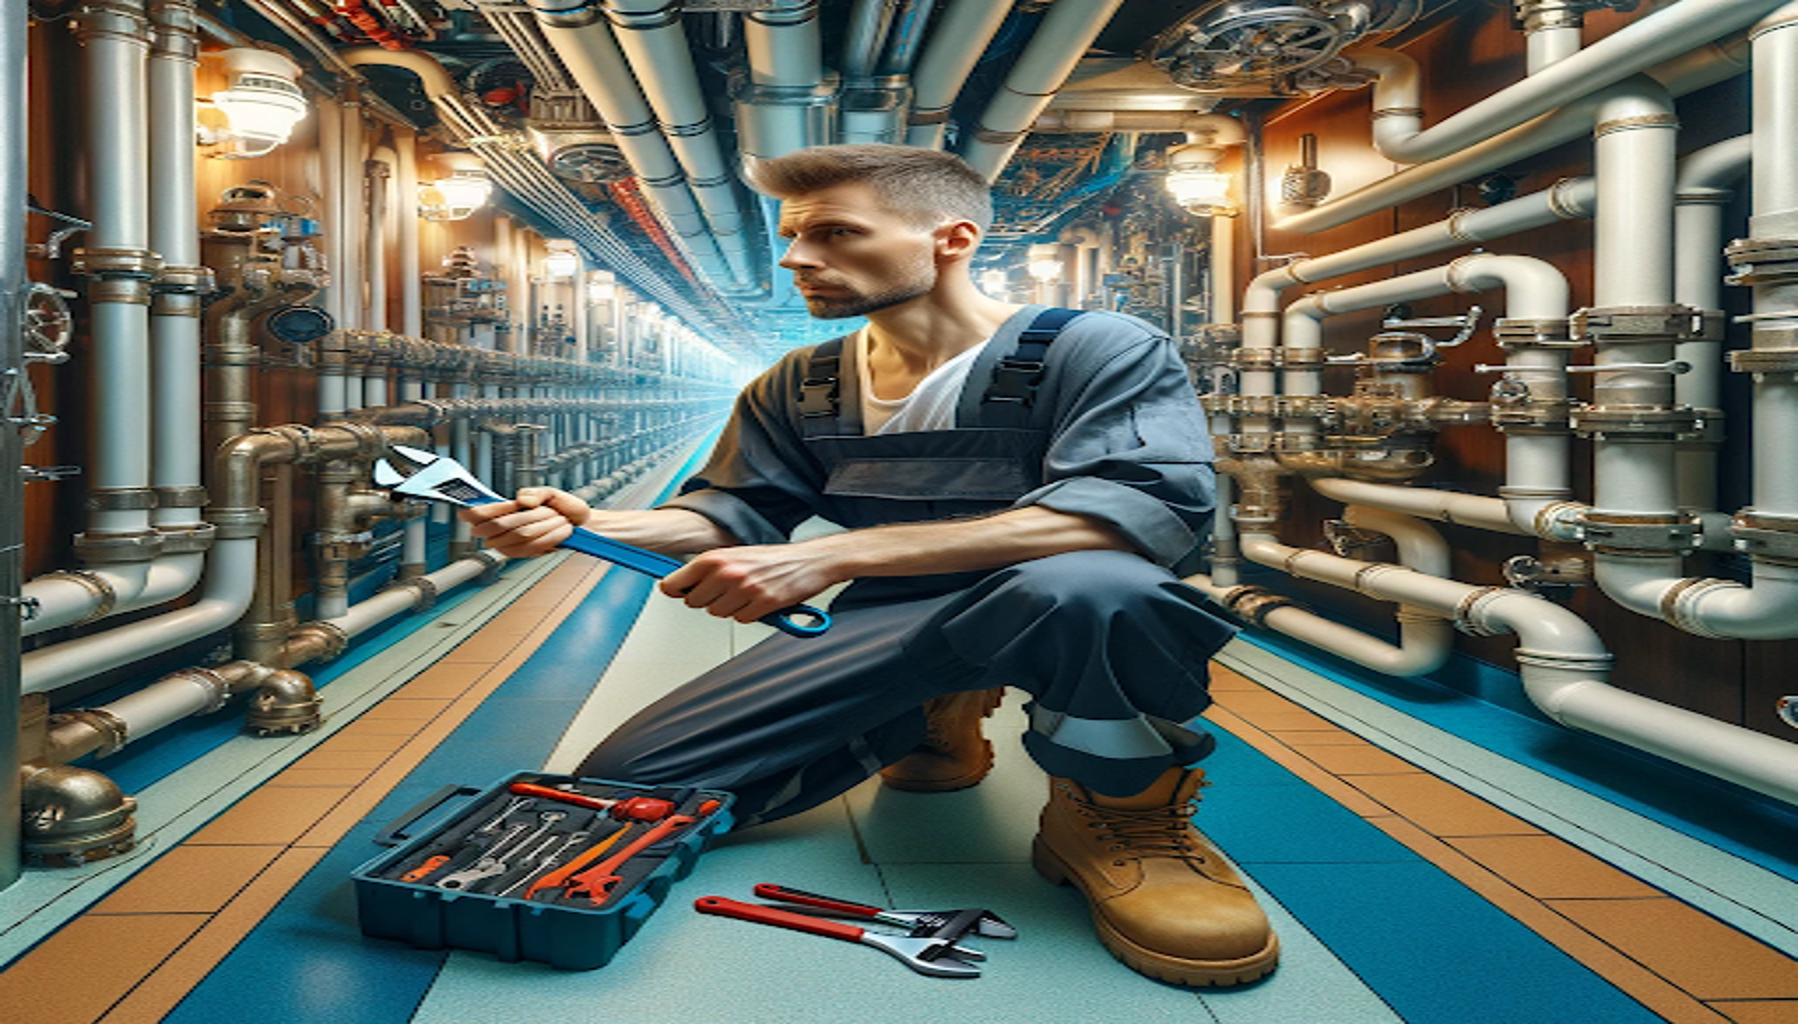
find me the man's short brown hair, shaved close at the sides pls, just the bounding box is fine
[746,142,992,234]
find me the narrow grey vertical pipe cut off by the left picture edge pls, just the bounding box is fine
[0,4,31,889]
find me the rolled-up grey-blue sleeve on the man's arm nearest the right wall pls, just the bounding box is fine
[1016,336,1215,566]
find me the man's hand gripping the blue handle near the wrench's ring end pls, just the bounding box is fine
[662,543,850,622]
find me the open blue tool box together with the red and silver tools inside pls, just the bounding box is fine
[352,772,732,970]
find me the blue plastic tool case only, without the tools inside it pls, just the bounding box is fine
[352,772,732,970]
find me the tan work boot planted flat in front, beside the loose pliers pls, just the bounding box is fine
[1032,769,1280,984]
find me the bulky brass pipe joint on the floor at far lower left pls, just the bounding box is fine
[20,765,137,864]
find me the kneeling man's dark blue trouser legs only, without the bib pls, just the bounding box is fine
[579,552,1233,825]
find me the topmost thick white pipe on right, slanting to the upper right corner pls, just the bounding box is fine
[1356,0,1782,163]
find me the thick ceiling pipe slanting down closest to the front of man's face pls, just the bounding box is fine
[595,0,761,293]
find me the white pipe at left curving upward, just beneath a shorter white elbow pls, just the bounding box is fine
[20,537,255,693]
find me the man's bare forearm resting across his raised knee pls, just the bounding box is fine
[795,505,1136,580]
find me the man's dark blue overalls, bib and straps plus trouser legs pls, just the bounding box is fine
[579,309,1233,825]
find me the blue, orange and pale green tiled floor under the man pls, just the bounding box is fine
[0,456,1798,1024]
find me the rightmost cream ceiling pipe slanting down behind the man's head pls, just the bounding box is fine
[962,0,1124,181]
